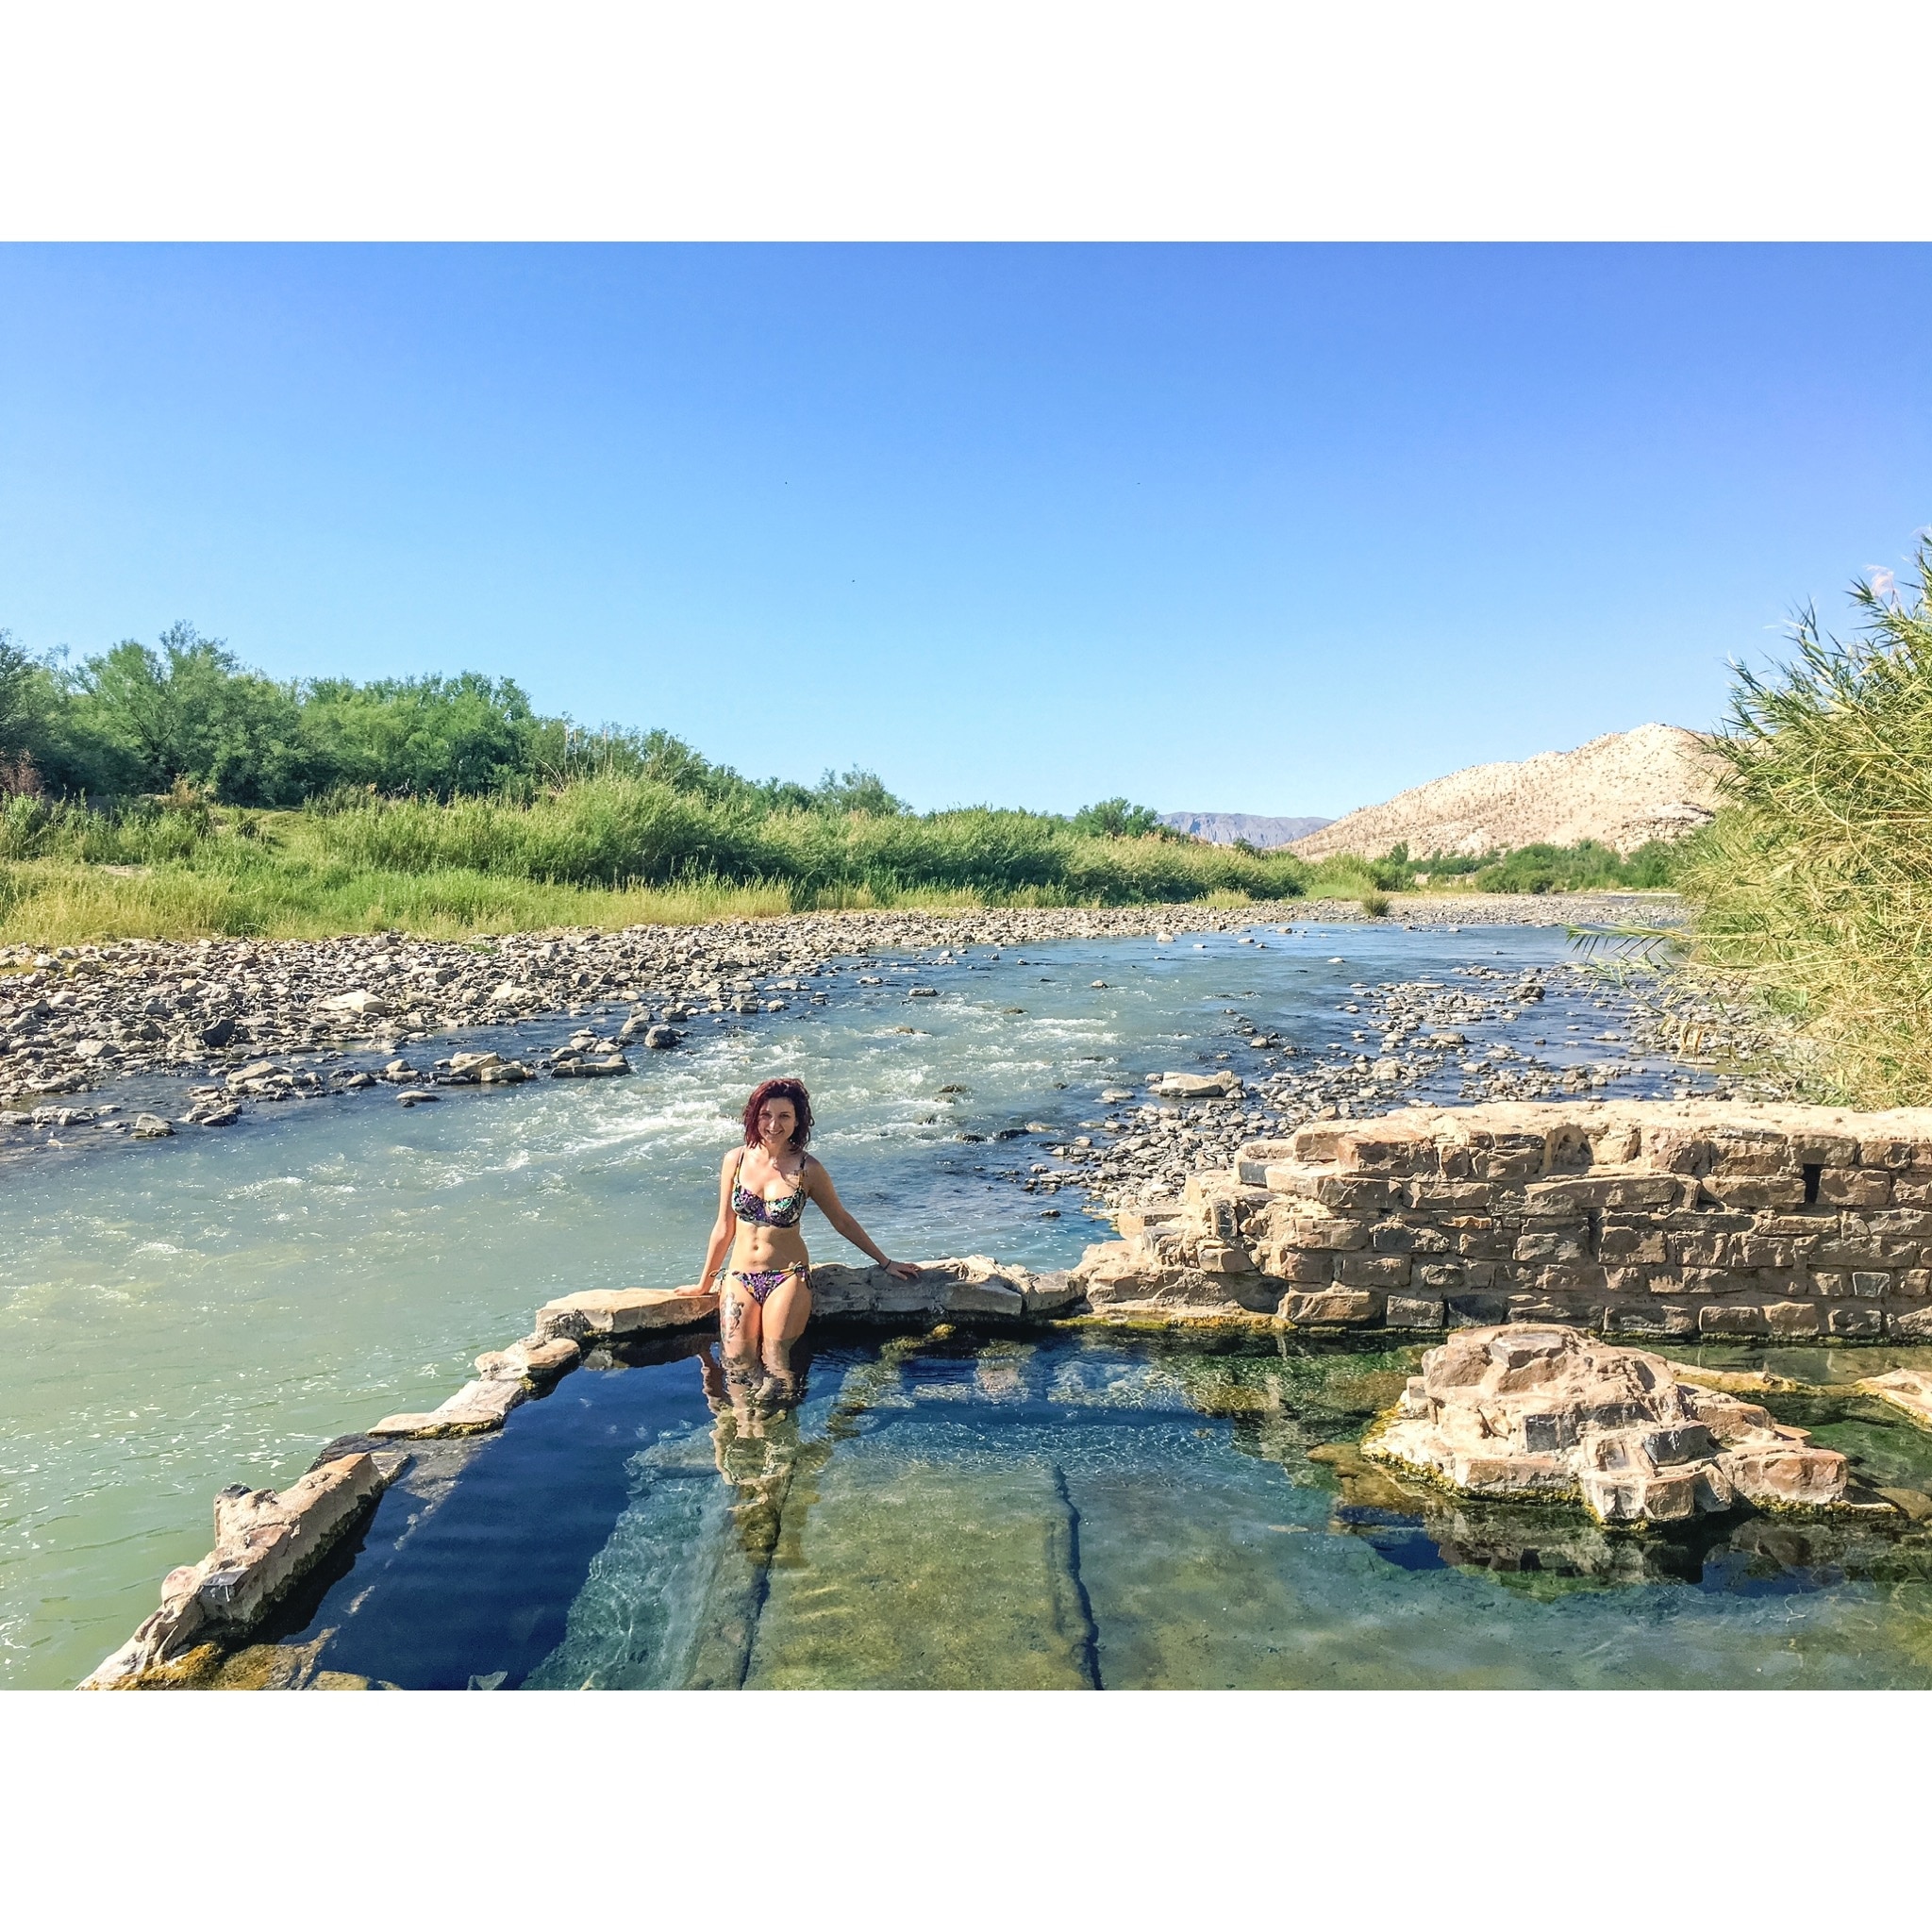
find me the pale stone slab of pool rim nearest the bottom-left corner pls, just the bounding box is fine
[81,1453,404,1690]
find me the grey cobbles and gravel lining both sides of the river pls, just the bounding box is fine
[0,894,1770,1158]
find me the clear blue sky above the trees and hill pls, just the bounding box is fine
[0,245,1932,815]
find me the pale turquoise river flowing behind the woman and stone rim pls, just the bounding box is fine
[0,911,1739,1685]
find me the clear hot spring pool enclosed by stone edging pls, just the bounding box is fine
[195,1329,1932,1690]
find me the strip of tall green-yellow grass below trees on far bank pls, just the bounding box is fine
[0,774,1307,944]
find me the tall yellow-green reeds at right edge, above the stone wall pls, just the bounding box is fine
[1677,539,1932,1105]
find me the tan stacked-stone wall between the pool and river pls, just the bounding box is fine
[1074,1101,1932,1341]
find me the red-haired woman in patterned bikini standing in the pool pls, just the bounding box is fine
[699,1080,918,1397]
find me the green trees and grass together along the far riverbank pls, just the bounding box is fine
[0,625,1665,944]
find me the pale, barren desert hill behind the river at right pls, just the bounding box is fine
[1294,724,1722,858]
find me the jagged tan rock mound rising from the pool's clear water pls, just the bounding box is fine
[1364,1324,1846,1523]
